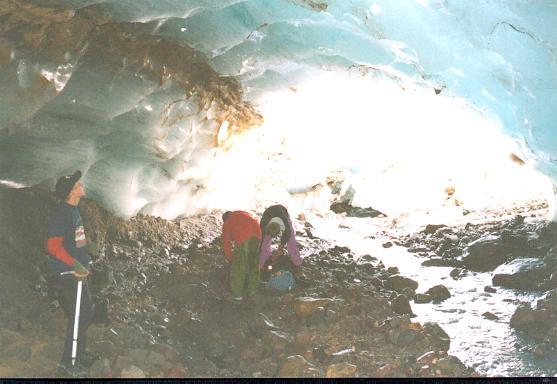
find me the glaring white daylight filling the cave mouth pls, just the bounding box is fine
[244,73,552,224]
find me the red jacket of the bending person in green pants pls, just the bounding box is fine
[222,211,261,263]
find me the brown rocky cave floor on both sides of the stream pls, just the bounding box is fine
[5,189,544,378]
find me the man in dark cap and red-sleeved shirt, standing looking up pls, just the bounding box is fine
[47,171,94,373]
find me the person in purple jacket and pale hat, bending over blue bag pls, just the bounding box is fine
[259,204,302,275]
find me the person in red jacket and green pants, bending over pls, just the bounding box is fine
[222,211,261,300]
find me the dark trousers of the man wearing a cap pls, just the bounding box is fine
[54,275,95,366]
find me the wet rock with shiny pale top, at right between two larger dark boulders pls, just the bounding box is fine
[492,258,551,290]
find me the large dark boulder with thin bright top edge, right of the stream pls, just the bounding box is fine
[462,235,512,272]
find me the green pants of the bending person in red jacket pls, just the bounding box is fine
[230,237,259,297]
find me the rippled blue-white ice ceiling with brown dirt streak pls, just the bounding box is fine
[0,0,557,217]
